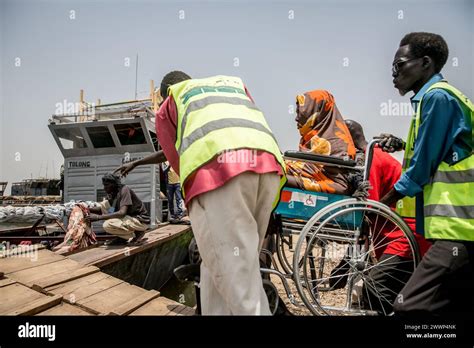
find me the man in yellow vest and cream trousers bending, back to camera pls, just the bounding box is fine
[115,71,286,315]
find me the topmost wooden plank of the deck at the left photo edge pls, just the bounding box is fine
[0,250,65,275]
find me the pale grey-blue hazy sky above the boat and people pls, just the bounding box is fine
[0,0,474,192]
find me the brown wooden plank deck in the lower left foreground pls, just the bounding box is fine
[0,225,194,316]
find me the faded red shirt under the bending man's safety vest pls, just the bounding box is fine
[155,90,283,205]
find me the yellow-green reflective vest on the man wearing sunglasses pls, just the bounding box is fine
[407,81,474,241]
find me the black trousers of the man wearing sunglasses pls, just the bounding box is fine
[394,240,474,315]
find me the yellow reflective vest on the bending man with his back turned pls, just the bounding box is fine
[169,76,286,206]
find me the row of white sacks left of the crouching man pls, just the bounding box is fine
[0,201,98,224]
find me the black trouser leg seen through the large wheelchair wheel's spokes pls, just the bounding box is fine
[362,254,413,315]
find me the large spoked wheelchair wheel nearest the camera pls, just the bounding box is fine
[293,199,419,315]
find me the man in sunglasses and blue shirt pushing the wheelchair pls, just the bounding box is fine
[379,33,474,315]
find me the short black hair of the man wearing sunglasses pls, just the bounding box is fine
[400,32,449,73]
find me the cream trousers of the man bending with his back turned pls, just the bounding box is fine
[189,172,280,315]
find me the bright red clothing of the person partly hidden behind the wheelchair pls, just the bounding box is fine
[369,147,431,258]
